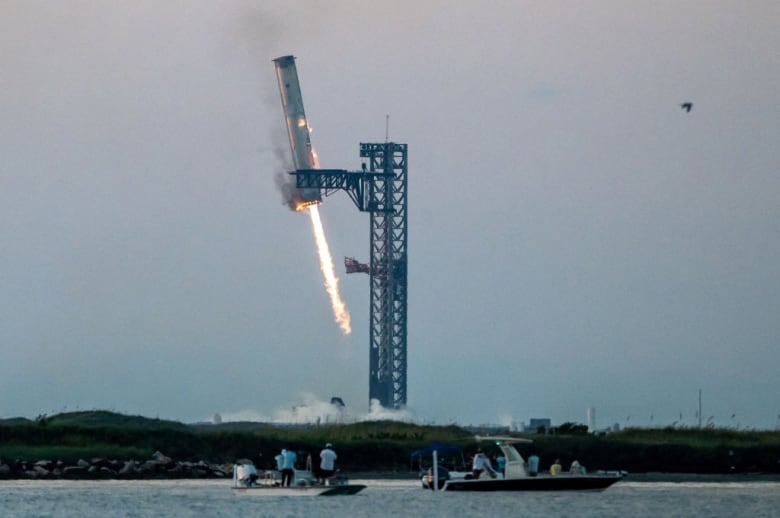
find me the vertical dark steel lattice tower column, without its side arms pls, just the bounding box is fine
[360,143,407,409]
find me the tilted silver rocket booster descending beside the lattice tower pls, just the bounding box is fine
[274,56,322,202]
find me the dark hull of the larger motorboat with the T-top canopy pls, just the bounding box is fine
[443,475,623,491]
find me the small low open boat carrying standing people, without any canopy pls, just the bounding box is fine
[231,464,366,496]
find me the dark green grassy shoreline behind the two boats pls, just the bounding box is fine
[0,411,780,480]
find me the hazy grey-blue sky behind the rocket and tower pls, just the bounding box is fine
[0,0,780,428]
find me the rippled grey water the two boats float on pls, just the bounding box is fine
[0,480,780,518]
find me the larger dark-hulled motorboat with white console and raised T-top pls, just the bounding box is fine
[430,436,626,491]
